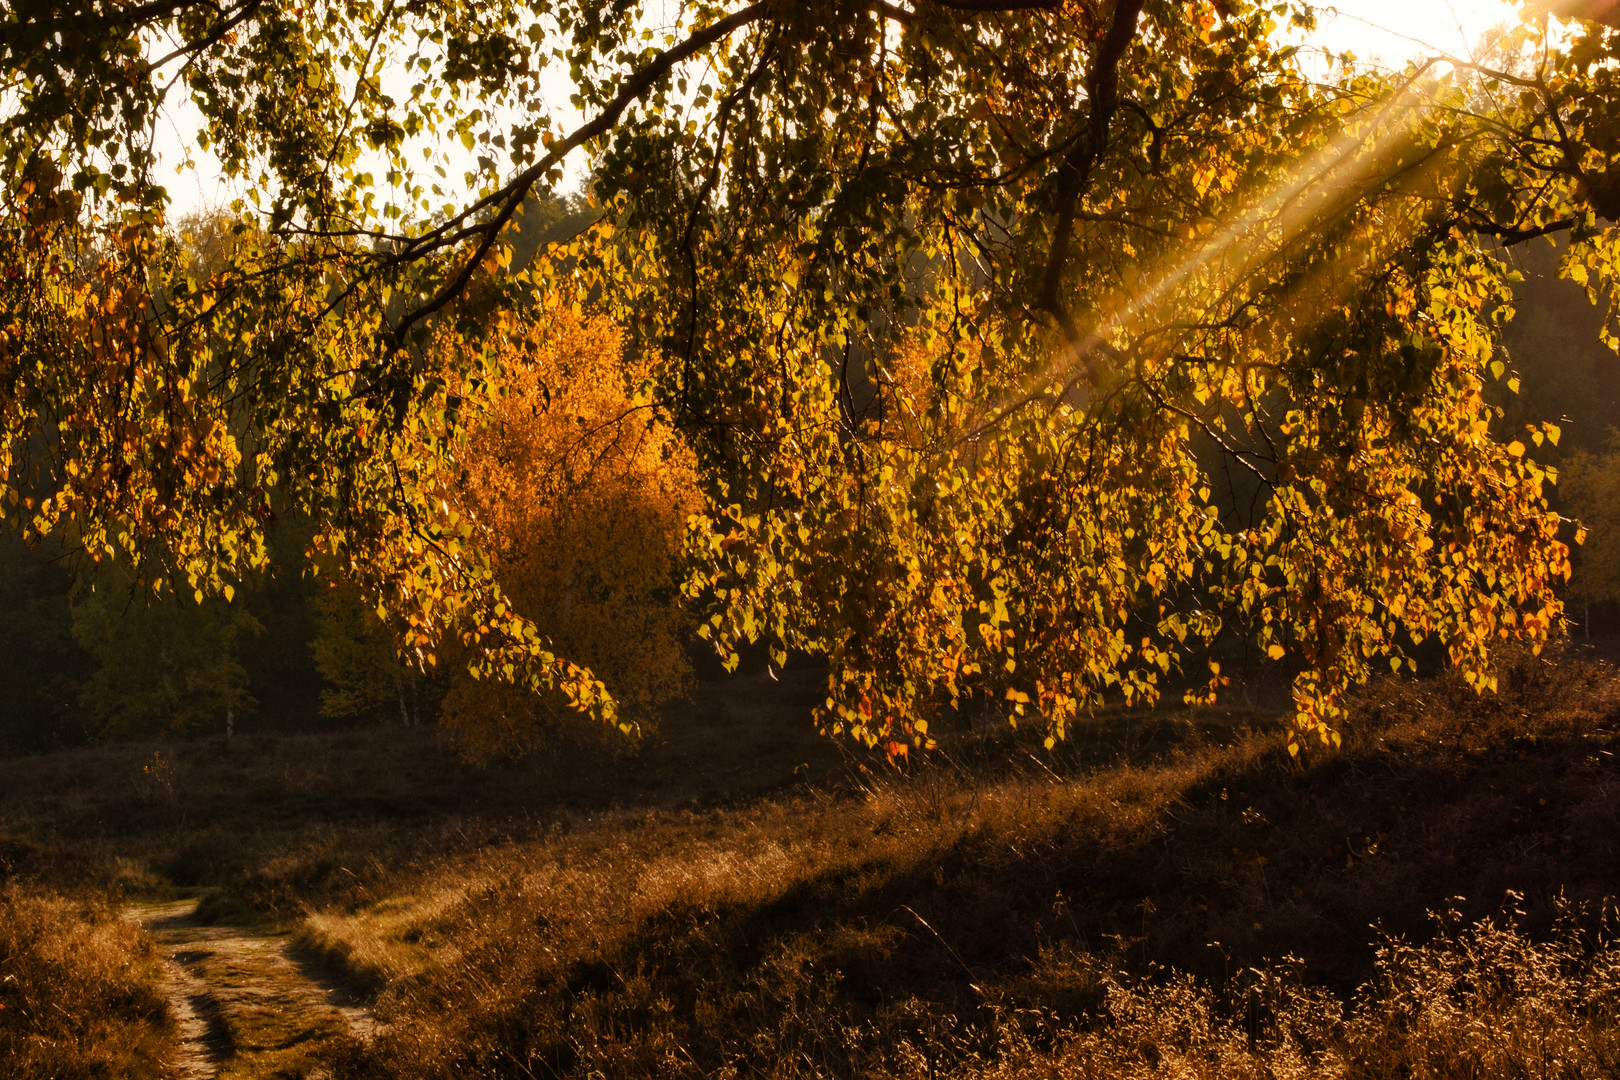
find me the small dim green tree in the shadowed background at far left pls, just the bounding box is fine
[73,572,259,738]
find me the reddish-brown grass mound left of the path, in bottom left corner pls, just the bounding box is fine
[0,884,173,1080]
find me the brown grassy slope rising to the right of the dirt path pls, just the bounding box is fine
[306,659,1620,1080]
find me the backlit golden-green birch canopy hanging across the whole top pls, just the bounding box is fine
[0,0,1620,745]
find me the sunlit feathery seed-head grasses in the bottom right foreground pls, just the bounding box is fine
[886,916,1620,1080]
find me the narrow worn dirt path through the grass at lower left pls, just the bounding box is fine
[126,900,376,1080]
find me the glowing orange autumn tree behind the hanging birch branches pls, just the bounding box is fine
[444,303,698,753]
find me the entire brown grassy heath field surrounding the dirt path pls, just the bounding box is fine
[0,659,1620,1078]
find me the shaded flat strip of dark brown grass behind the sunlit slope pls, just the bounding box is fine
[0,663,842,918]
